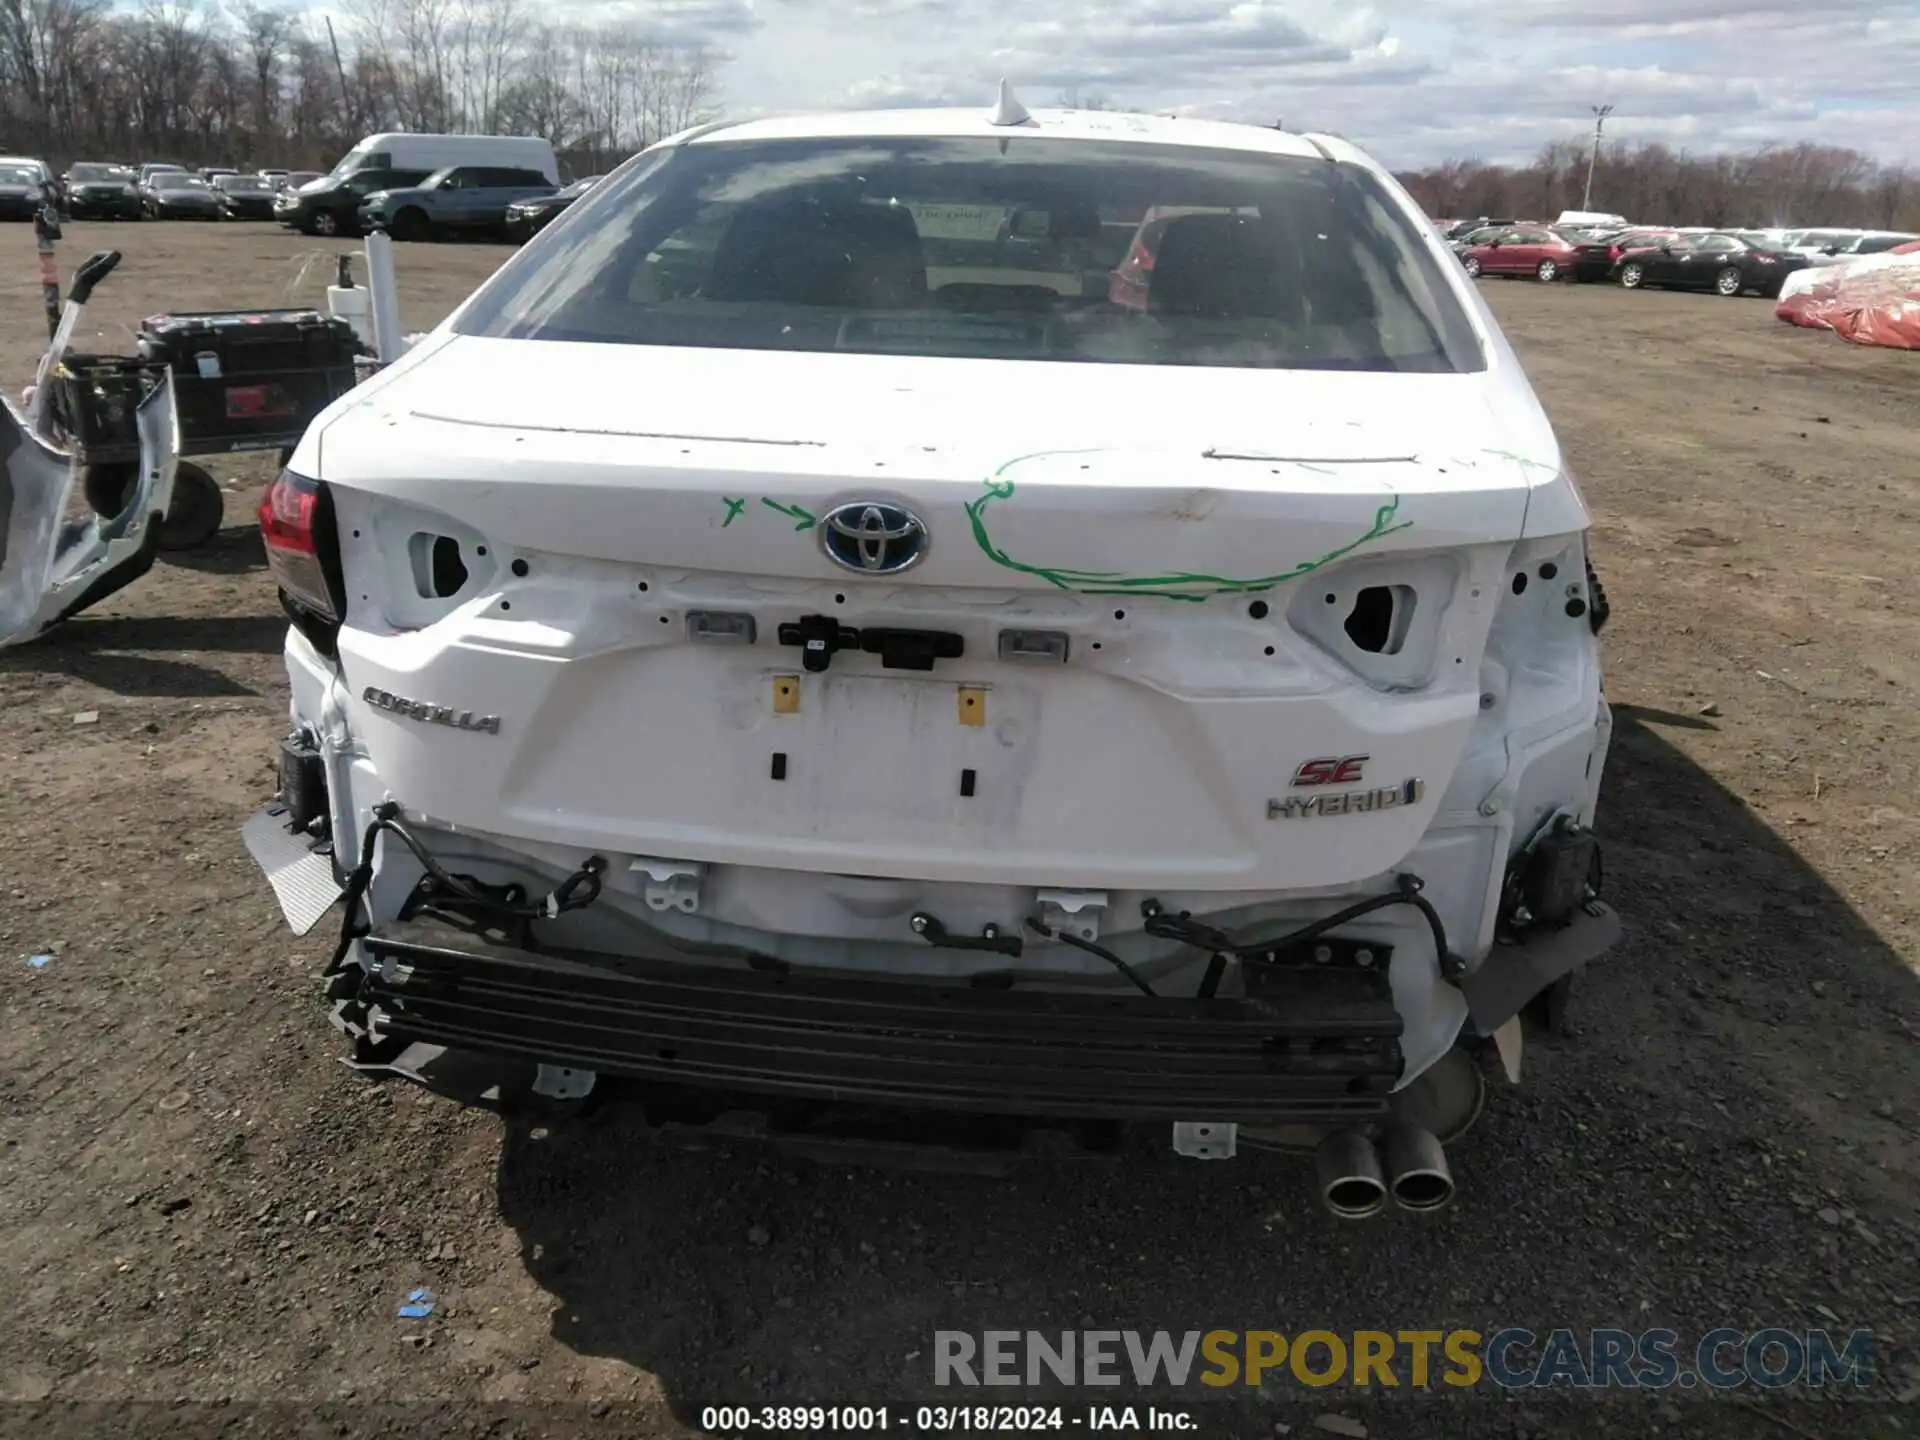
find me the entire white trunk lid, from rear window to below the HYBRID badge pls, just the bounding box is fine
[307,336,1559,893]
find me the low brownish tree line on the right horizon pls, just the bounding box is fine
[1398,140,1920,232]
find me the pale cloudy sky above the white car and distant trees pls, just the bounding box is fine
[589,0,1920,167]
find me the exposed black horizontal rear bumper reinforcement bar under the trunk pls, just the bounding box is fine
[353,918,1402,1125]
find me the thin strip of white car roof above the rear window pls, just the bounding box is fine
[670,106,1344,167]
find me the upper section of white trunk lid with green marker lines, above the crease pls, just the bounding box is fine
[321,338,1559,593]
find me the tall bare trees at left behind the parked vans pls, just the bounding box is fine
[0,0,716,173]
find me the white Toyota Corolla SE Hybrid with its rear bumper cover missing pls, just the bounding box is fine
[248,96,1617,1217]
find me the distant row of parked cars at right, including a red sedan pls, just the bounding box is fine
[1438,219,1920,298]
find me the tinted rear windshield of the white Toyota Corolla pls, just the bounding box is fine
[455,134,1484,371]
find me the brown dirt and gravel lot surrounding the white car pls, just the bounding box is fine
[0,225,1920,1436]
